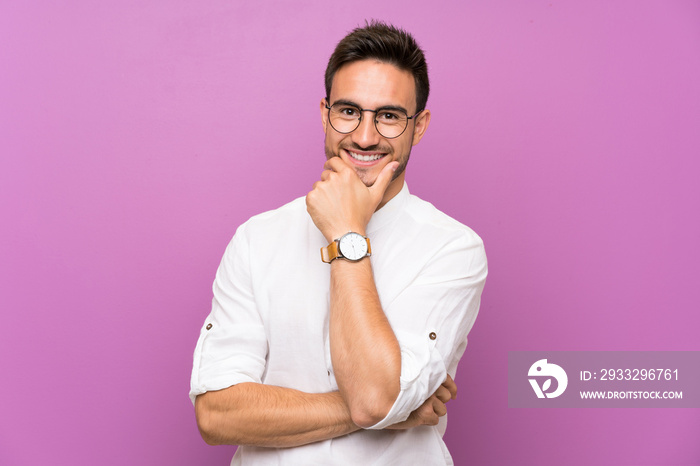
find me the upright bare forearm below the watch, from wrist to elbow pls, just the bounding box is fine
[330,258,401,427]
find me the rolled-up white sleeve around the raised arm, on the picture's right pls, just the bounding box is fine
[370,231,487,429]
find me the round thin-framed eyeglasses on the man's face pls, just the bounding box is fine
[326,101,423,139]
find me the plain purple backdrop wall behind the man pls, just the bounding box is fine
[0,0,700,465]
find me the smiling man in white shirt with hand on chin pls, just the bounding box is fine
[190,22,486,465]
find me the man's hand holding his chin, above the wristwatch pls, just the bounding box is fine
[306,157,398,243]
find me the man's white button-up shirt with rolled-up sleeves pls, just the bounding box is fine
[190,184,487,466]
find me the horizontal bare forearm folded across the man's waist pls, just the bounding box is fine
[195,383,358,447]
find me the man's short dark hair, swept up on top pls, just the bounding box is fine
[326,20,430,112]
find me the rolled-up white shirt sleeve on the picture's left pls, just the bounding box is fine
[190,225,268,403]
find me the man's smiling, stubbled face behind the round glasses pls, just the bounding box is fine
[321,60,430,194]
